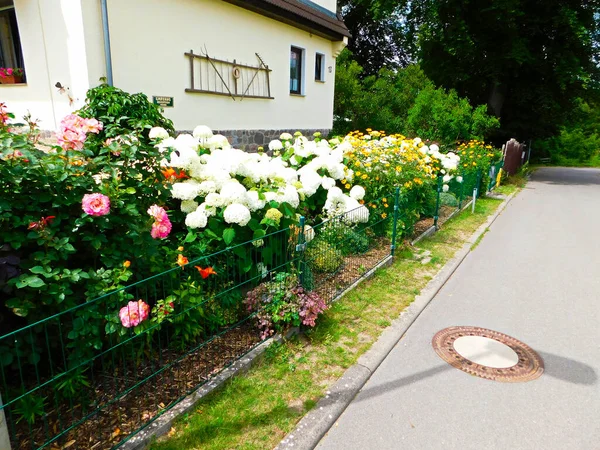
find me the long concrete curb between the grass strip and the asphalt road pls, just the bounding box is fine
[275,193,516,450]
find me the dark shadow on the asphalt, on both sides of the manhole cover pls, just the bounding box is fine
[344,352,598,402]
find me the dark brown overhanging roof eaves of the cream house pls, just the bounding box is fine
[224,0,350,41]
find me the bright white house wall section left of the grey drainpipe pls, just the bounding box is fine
[0,0,104,130]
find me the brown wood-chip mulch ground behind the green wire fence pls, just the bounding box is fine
[9,238,390,450]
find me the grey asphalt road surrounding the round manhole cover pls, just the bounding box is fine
[317,168,600,450]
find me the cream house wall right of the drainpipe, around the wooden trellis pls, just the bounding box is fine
[108,0,337,130]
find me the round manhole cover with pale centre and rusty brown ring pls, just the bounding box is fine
[432,327,544,383]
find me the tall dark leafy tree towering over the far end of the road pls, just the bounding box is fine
[410,0,600,138]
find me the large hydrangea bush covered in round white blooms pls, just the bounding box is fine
[152,126,369,245]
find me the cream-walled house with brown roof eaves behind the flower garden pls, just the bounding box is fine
[0,0,349,149]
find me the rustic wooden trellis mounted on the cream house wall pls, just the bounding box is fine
[185,50,274,100]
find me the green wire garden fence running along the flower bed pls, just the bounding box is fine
[0,162,502,450]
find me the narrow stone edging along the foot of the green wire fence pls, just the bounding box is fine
[117,255,393,450]
